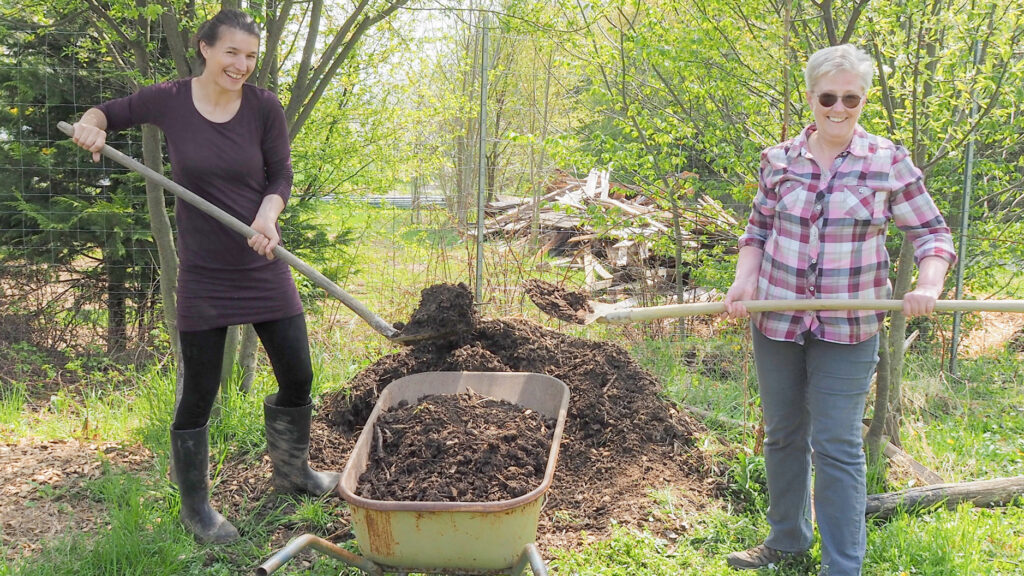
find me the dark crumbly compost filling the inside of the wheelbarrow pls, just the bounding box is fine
[356,392,555,502]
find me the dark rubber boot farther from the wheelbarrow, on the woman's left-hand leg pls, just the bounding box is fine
[171,424,239,544]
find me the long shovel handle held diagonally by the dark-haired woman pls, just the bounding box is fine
[57,122,398,338]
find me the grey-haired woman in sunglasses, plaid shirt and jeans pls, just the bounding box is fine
[724,44,956,576]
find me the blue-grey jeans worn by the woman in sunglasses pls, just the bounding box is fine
[752,327,879,576]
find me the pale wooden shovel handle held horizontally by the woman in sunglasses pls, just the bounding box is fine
[599,299,1024,324]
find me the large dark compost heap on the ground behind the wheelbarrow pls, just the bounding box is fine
[311,284,721,541]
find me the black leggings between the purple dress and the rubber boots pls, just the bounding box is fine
[172,314,313,430]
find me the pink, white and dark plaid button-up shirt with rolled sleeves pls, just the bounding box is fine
[739,124,956,344]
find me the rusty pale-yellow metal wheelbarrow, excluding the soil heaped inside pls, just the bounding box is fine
[256,372,569,576]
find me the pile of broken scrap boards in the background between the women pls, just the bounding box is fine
[485,166,738,291]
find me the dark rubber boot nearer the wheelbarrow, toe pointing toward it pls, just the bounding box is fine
[263,394,341,496]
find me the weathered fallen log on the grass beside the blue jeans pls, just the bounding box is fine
[864,476,1024,520]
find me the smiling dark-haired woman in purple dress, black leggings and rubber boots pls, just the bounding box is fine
[74,9,339,543]
